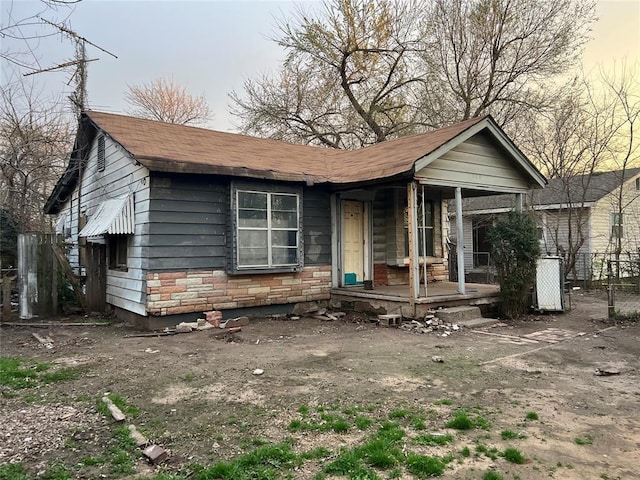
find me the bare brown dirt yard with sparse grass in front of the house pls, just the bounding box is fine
[0,292,640,480]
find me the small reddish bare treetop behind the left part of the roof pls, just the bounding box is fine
[125,78,211,125]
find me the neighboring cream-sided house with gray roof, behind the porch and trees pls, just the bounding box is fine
[454,168,640,280]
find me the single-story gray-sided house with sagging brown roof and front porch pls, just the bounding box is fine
[45,111,546,327]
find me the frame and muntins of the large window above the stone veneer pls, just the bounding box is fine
[228,182,304,274]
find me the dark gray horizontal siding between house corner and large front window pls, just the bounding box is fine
[142,174,229,271]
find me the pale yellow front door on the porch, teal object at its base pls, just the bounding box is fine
[342,200,365,285]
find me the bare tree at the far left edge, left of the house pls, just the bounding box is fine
[0,82,73,232]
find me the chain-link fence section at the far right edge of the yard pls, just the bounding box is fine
[607,257,640,318]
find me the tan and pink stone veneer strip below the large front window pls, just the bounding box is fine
[147,265,331,315]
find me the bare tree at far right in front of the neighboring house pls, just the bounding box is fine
[521,65,640,278]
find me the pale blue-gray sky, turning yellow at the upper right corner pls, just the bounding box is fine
[0,0,640,131]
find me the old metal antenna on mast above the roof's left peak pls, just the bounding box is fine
[24,17,118,119]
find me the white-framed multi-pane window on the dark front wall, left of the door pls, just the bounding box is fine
[235,190,300,269]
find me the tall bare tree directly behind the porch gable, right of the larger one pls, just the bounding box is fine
[424,0,595,125]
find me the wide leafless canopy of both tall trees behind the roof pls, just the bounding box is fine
[231,0,594,148]
